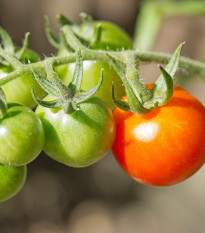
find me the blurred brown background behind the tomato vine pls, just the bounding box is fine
[0,0,205,233]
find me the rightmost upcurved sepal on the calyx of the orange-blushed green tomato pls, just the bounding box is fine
[73,69,103,104]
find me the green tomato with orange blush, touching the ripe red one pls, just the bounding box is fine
[36,95,115,167]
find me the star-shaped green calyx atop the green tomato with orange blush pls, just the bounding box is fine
[31,50,103,114]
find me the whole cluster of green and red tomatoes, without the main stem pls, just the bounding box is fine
[0,14,205,202]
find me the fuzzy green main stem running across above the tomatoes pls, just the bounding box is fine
[0,50,205,86]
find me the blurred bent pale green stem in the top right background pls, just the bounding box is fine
[133,0,205,50]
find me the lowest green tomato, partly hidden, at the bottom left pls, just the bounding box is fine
[0,164,26,202]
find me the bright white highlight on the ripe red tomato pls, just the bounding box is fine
[133,122,159,142]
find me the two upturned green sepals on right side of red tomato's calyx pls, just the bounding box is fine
[144,43,184,108]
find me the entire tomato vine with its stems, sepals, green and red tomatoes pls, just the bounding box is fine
[0,2,205,201]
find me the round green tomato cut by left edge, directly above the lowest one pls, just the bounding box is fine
[0,104,44,166]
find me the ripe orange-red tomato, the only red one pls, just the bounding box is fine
[112,86,205,186]
